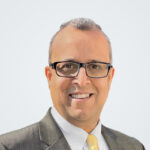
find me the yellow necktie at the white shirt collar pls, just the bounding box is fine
[86,134,98,150]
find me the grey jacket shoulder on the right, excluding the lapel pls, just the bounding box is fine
[102,126,145,150]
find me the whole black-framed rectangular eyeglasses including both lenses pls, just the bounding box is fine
[49,61,112,78]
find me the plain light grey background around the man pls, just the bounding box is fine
[0,0,150,149]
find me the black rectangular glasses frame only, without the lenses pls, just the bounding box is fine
[49,61,113,78]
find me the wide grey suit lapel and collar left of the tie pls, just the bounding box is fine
[39,109,71,150]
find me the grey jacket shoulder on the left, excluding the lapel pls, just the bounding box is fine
[0,123,44,150]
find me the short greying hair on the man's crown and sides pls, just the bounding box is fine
[48,18,112,63]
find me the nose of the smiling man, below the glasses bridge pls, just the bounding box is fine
[73,67,90,87]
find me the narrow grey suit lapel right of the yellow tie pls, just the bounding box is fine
[102,125,123,150]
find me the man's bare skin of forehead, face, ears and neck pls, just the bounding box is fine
[45,26,114,133]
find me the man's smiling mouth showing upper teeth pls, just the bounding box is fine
[69,93,93,100]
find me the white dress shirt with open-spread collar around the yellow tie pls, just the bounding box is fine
[51,107,109,150]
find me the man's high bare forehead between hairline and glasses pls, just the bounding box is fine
[51,26,110,62]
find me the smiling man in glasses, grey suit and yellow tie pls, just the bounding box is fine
[0,18,144,150]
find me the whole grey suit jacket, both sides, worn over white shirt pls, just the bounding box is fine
[0,109,144,150]
